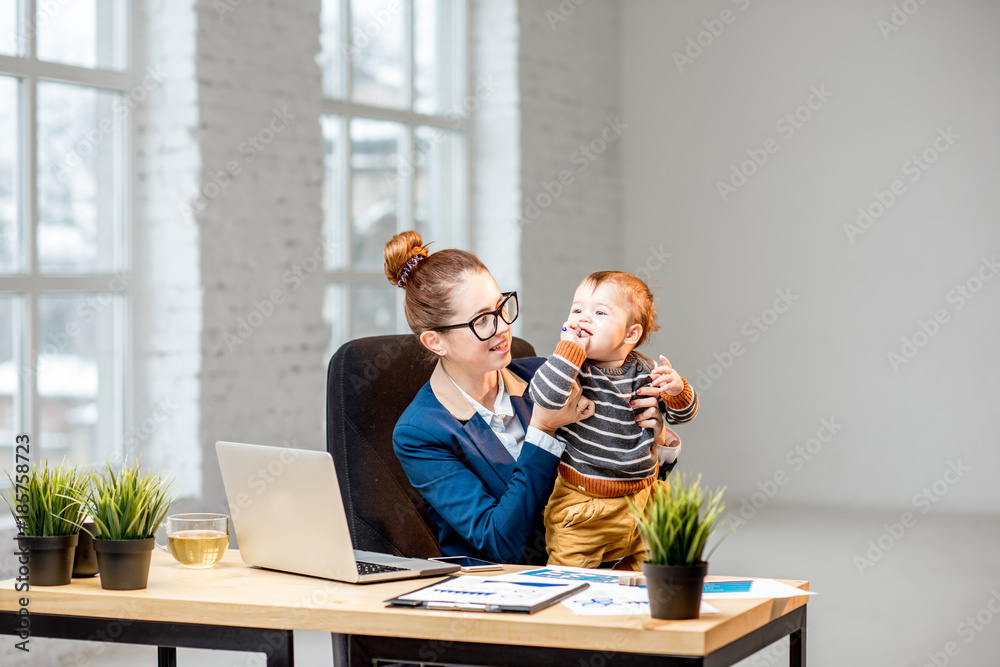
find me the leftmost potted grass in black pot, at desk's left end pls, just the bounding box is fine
[4,461,87,586]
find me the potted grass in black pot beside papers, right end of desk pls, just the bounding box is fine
[630,475,726,620]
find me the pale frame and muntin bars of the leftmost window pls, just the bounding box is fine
[0,0,142,486]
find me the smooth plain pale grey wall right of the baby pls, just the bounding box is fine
[620,0,1000,513]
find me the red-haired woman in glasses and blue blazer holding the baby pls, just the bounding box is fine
[384,231,672,564]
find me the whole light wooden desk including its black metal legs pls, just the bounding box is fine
[0,550,808,667]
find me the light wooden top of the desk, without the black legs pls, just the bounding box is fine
[0,550,809,655]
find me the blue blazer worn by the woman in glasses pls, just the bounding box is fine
[392,358,559,564]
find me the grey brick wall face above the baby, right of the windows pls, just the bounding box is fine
[518,0,626,355]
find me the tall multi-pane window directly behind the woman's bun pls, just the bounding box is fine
[319,0,469,358]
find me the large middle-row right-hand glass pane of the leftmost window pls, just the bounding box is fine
[38,83,125,273]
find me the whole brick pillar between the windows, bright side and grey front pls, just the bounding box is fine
[126,0,325,510]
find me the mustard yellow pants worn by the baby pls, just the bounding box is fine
[545,476,670,571]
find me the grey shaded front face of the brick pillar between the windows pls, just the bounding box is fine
[189,0,326,507]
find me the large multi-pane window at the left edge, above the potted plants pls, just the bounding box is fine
[0,0,133,472]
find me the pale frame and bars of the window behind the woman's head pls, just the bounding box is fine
[320,0,475,354]
